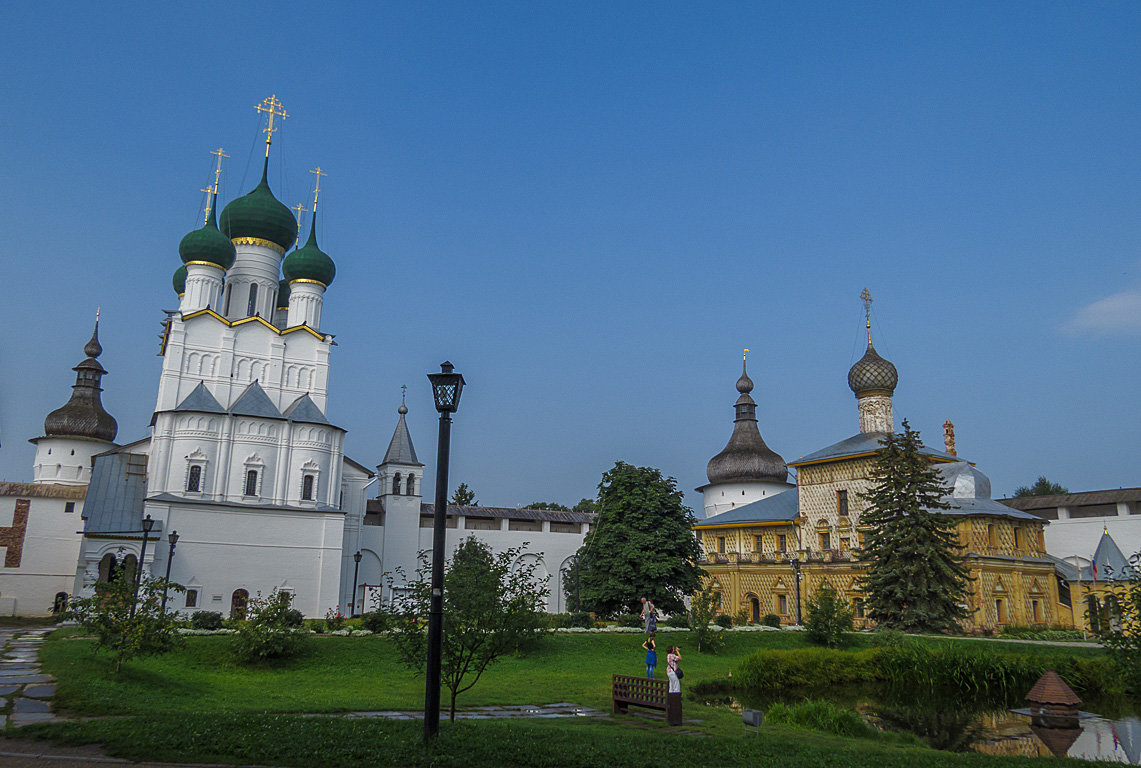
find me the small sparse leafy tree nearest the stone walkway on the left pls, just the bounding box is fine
[66,568,183,672]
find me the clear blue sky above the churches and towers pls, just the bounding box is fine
[0,2,1141,508]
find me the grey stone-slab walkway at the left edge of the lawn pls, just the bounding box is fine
[0,626,58,725]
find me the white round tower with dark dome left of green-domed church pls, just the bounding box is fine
[29,318,119,485]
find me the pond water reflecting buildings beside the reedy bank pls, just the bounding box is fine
[698,686,1141,766]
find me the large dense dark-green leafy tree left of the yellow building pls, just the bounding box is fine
[578,461,703,614]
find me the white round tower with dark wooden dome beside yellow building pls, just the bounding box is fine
[697,362,793,517]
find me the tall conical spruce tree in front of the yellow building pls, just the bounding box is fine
[859,420,970,632]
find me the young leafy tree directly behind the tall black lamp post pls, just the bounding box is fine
[389,537,548,720]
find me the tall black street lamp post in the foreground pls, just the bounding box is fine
[424,362,466,742]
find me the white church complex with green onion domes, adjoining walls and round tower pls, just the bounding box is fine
[0,98,593,617]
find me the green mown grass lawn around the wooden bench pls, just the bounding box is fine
[9,630,1122,768]
